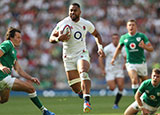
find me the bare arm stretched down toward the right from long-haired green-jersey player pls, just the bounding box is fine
[14,61,40,85]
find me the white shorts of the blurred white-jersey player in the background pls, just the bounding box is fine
[106,69,124,81]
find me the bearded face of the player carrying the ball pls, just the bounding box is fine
[69,5,81,22]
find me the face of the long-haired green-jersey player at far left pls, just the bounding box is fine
[11,32,21,47]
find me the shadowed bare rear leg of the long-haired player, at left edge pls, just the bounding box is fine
[0,89,10,104]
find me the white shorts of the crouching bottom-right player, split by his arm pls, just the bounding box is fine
[131,99,158,115]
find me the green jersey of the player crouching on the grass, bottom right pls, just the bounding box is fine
[138,79,160,107]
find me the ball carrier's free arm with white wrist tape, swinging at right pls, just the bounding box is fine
[92,29,105,57]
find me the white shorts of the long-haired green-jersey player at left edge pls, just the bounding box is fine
[0,75,16,91]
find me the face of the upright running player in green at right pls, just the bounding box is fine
[127,22,137,35]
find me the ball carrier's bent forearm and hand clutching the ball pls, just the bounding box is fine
[49,28,69,43]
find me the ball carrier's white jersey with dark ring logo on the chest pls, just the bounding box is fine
[51,16,95,58]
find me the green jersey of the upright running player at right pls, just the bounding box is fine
[119,33,149,64]
